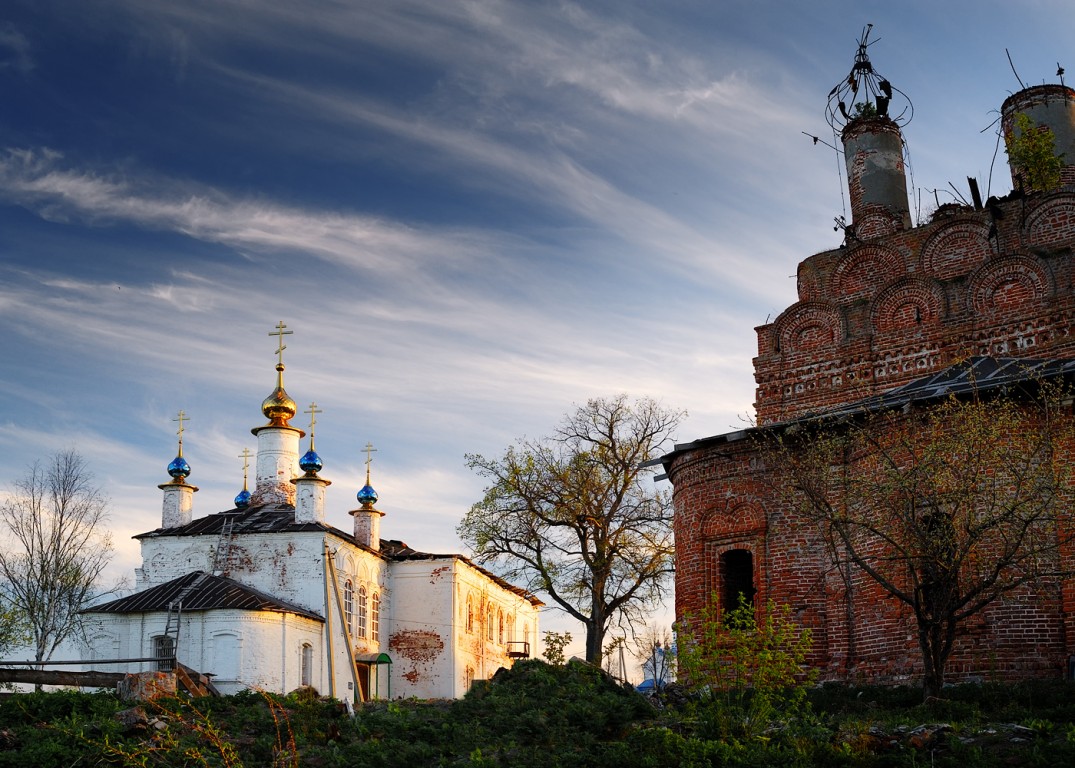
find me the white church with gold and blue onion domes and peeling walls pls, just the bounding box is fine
[83,323,543,701]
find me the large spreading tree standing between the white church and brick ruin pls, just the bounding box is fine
[458,395,685,664]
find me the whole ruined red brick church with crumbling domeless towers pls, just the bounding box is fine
[663,38,1075,680]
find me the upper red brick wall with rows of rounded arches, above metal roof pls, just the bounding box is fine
[754,190,1075,424]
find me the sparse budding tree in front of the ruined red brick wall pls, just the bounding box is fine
[763,381,1075,698]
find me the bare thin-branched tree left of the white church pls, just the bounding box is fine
[0,451,113,663]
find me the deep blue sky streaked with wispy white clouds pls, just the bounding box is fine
[0,0,1075,641]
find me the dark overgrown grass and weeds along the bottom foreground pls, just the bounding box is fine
[0,660,1075,768]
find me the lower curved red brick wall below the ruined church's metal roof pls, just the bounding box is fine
[671,423,1075,682]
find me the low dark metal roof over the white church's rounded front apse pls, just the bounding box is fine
[84,571,325,622]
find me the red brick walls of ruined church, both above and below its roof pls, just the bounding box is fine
[667,182,1075,681]
